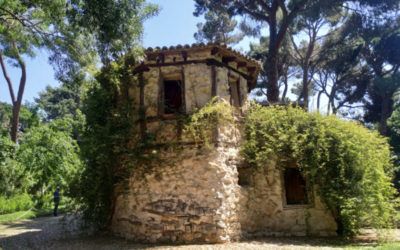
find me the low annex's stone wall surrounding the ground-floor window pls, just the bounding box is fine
[239,161,336,237]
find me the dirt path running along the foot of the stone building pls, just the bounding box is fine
[0,216,396,250]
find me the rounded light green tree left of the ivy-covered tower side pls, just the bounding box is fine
[17,124,82,206]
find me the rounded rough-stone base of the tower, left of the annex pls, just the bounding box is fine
[112,124,240,242]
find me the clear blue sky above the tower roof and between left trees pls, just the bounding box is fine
[0,0,256,102]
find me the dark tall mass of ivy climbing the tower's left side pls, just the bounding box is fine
[76,52,138,227]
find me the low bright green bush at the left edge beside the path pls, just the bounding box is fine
[0,194,33,214]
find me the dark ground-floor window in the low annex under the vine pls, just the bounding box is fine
[284,168,308,205]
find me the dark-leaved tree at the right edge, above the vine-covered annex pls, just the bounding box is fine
[361,18,400,135]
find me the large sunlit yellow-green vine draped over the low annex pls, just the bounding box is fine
[242,105,395,235]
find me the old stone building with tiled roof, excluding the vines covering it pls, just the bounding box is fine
[112,44,336,243]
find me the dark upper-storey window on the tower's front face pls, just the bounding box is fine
[164,80,183,114]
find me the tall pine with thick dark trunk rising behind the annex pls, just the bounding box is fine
[194,0,399,103]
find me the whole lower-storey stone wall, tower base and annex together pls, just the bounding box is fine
[112,120,336,243]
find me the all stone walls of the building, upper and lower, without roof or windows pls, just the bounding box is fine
[112,55,336,242]
